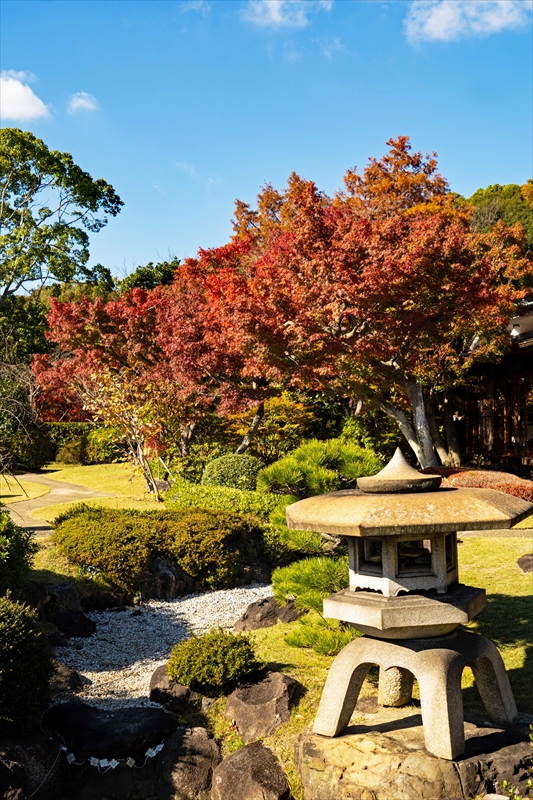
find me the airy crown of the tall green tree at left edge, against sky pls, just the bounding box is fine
[0,128,123,311]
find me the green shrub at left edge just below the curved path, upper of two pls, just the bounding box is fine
[0,511,39,598]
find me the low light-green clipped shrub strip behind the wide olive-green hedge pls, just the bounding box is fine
[165,481,280,520]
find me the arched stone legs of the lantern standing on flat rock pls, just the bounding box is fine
[313,631,517,760]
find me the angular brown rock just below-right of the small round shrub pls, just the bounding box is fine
[226,672,299,744]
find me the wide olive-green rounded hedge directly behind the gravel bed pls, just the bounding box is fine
[55,503,262,591]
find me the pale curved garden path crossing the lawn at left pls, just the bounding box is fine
[4,472,110,537]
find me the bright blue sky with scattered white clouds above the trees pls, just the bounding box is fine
[0,0,533,276]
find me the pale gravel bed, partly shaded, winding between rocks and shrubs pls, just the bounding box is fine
[56,584,272,709]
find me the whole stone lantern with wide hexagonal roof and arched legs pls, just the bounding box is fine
[286,449,533,759]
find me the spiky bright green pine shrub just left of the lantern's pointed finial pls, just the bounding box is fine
[257,439,382,499]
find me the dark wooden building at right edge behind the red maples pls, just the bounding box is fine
[465,310,533,474]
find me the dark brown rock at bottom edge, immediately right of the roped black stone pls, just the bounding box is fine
[156,728,222,800]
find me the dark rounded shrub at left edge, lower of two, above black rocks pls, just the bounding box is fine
[0,597,53,723]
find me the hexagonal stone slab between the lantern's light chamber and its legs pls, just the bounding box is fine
[324,583,487,639]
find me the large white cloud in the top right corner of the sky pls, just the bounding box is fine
[404,0,533,42]
